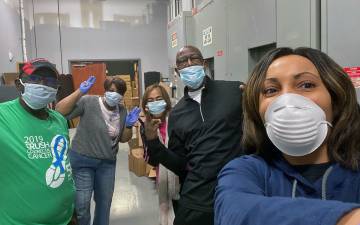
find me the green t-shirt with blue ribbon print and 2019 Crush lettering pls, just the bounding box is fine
[0,99,75,225]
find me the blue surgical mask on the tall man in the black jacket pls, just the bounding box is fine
[179,66,205,89]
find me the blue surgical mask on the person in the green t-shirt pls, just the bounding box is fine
[20,80,57,110]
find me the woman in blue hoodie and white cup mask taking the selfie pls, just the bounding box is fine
[215,48,360,225]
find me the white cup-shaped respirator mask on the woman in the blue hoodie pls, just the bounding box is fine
[265,93,332,156]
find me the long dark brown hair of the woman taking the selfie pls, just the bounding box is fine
[242,47,360,170]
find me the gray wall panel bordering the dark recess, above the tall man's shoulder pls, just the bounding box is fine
[227,0,276,81]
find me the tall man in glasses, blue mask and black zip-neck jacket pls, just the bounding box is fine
[145,46,242,225]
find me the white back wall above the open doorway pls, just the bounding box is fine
[28,0,168,79]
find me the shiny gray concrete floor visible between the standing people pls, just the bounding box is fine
[70,129,160,225]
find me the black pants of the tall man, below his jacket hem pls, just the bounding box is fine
[174,204,214,225]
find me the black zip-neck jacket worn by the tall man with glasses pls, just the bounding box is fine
[147,77,242,212]
